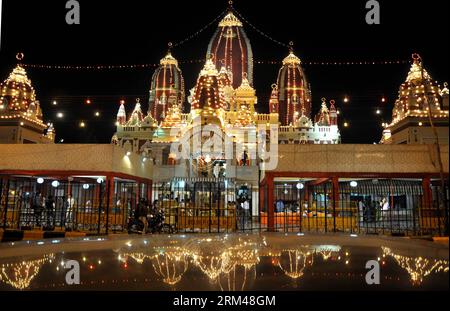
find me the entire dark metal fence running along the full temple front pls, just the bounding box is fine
[0,176,449,235]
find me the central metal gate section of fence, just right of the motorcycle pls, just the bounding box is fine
[153,178,261,233]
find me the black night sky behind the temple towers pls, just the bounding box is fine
[0,0,450,144]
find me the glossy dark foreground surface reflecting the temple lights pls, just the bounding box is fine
[0,234,449,291]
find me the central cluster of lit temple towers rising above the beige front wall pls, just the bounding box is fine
[113,8,340,164]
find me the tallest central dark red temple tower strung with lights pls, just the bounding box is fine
[208,4,253,89]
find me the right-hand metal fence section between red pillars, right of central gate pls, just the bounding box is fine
[262,179,449,235]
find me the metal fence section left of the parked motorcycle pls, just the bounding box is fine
[0,177,148,234]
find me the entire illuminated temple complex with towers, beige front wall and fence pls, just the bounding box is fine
[0,6,449,239]
